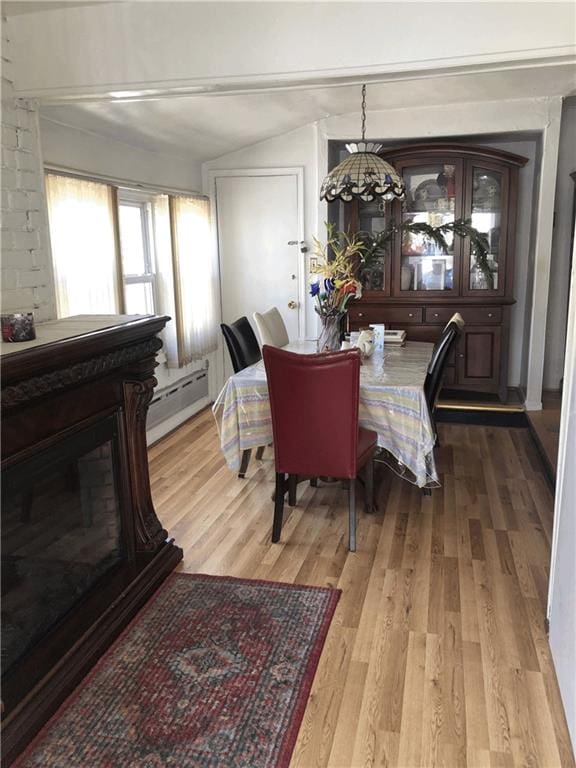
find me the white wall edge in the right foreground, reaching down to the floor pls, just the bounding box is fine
[548,226,576,751]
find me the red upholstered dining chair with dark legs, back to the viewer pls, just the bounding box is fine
[262,345,377,552]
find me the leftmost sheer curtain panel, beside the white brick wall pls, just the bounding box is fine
[46,173,123,317]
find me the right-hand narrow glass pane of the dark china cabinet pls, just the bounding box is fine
[463,165,508,295]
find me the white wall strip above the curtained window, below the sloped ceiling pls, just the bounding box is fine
[40,116,202,192]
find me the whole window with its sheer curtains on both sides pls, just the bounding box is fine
[46,173,218,367]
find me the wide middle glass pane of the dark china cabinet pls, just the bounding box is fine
[396,161,462,297]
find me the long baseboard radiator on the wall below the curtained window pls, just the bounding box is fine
[146,368,208,443]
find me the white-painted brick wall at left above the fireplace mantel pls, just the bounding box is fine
[0,18,56,321]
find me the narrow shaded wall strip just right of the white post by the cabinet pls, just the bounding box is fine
[544,99,576,389]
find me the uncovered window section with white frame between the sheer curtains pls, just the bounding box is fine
[118,198,158,315]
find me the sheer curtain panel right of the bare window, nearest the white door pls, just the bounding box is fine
[170,196,218,365]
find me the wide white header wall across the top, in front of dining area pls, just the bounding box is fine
[9,2,575,95]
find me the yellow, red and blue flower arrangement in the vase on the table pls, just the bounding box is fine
[310,224,365,317]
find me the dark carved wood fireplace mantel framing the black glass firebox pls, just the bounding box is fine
[1,316,182,764]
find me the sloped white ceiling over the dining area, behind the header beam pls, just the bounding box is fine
[41,64,576,162]
